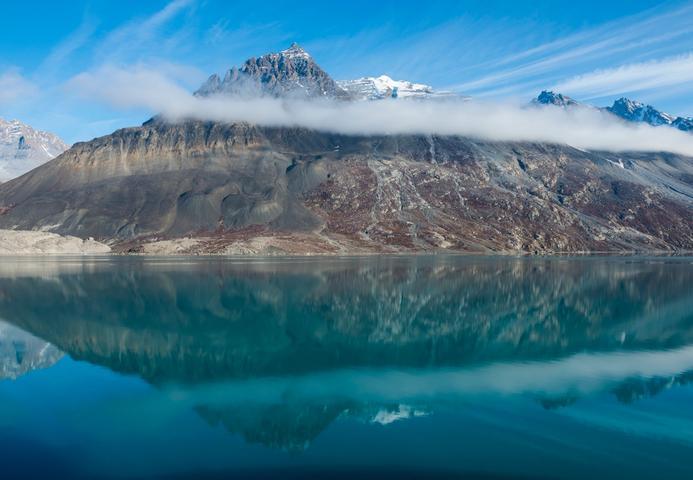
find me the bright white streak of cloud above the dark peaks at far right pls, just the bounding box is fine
[554,53,693,98]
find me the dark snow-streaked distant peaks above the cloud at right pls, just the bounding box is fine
[532,90,693,132]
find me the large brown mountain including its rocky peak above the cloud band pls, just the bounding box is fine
[0,45,693,254]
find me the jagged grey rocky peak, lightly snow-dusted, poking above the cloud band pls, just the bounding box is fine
[195,43,350,100]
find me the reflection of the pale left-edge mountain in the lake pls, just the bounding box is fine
[0,321,63,380]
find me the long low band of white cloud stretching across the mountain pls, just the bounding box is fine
[69,67,693,156]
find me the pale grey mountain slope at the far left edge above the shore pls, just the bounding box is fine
[0,118,69,181]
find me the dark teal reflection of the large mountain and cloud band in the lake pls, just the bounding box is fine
[0,256,693,476]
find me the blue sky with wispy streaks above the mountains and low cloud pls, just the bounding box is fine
[0,0,693,142]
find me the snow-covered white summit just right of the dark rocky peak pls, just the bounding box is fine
[337,75,459,100]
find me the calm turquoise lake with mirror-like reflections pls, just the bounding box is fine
[0,257,693,479]
